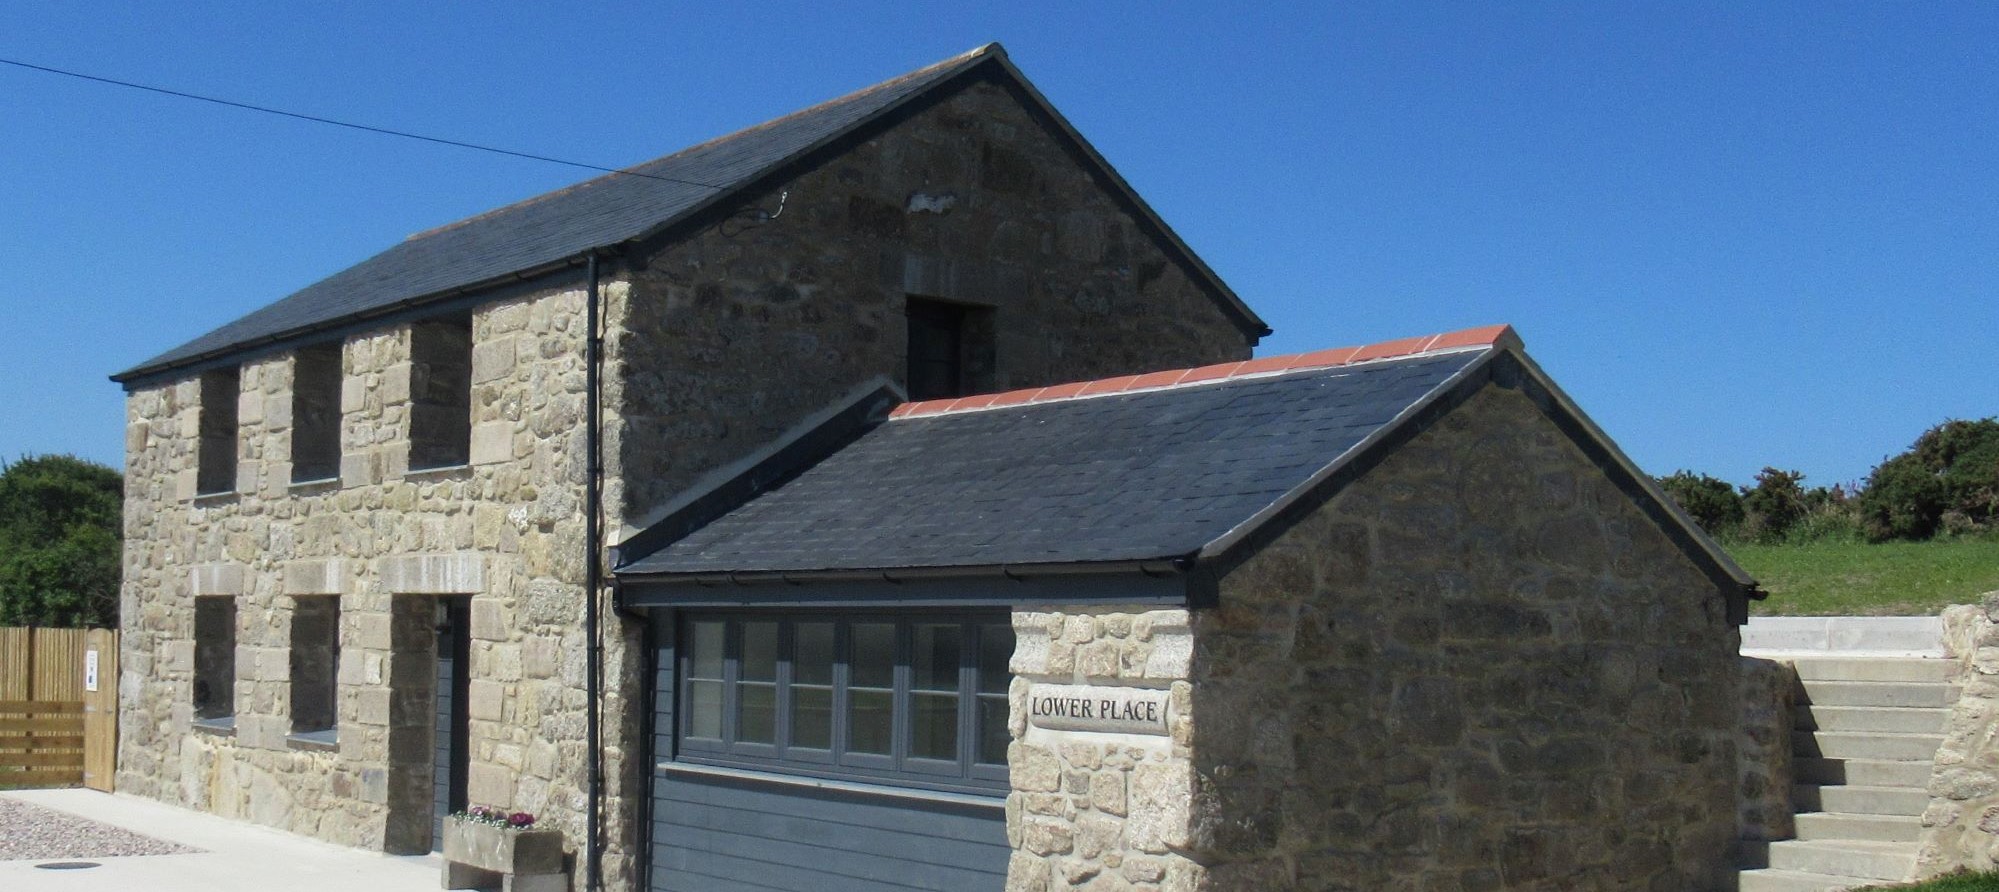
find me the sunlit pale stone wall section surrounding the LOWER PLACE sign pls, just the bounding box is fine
[1005,608,1199,892]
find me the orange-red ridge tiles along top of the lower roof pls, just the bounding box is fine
[890,324,1519,420]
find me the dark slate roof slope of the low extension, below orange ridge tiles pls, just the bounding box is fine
[620,350,1489,576]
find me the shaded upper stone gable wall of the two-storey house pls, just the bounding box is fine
[608,76,1251,528]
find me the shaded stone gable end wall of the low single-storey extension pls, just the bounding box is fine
[1175,384,1741,892]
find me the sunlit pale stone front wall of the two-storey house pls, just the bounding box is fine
[118,284,586,850]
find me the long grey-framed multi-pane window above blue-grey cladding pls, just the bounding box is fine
[680,612,1013,790]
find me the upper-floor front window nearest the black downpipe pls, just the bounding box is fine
[410,314,472,470]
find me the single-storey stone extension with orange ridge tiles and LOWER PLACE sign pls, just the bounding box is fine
[618,326,1753,892]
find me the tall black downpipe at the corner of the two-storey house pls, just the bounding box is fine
[584,252,604,892]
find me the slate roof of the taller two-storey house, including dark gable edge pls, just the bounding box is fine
[112,44,1269,382]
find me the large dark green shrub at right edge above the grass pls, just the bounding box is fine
[1859,418,1999,542]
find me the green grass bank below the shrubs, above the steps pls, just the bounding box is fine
[1729,538,1999,616]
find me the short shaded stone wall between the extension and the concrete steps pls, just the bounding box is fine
[1735,656,1797,842]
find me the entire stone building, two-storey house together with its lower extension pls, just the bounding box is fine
[114,46,1749,890]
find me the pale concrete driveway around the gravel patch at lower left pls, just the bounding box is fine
[0,790,440,892]
